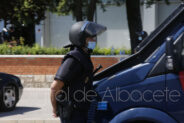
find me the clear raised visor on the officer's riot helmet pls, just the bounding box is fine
[85,22,107,37]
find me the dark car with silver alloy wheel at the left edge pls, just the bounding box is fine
[0,73,23,111]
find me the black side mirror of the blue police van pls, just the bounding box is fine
[166,37,174,71]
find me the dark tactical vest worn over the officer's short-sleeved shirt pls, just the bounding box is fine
[63,48,93,110]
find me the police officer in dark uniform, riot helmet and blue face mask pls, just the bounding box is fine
[51,21,106,123]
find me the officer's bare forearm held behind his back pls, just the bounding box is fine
[50,80,64,117]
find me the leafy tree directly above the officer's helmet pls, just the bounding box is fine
[51,0,100,21]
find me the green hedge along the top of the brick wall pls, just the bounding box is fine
[0,44,131,55]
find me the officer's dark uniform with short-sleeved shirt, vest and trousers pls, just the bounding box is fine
[55,47,93,123]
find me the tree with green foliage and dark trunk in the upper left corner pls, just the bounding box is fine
[0,0,52,45]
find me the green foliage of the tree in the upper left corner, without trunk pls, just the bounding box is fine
[0,0,52,25]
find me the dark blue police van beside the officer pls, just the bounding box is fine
[88,4,184,123]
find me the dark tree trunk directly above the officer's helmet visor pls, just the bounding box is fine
[87,0,97,21]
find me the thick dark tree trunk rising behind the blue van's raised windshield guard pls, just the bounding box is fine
[126,0,142,54]
